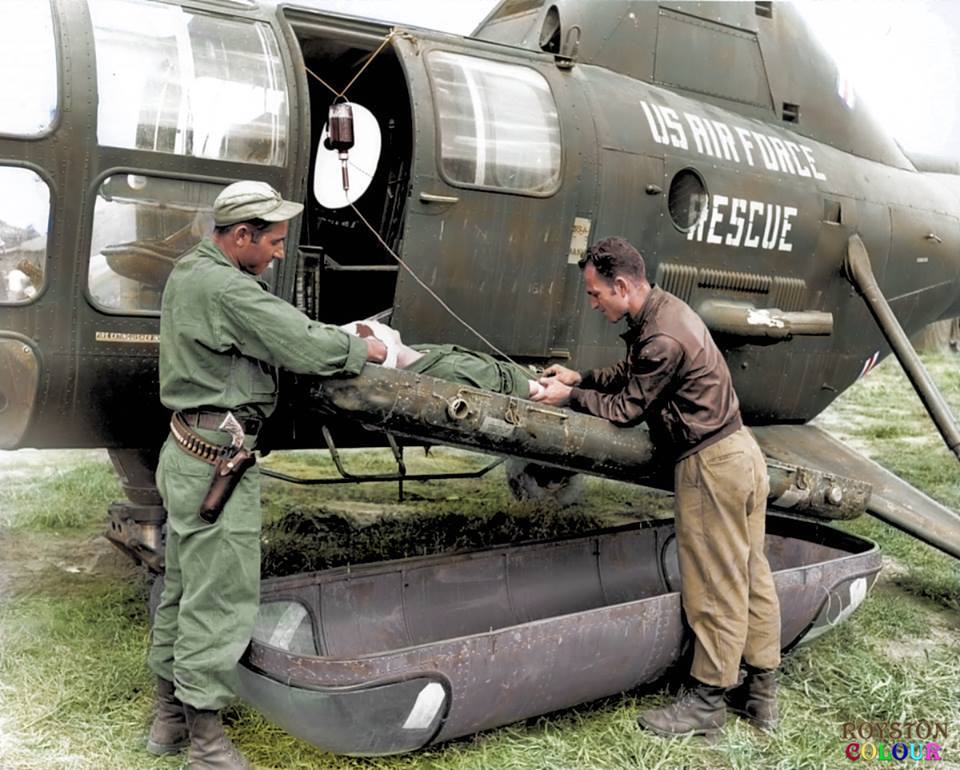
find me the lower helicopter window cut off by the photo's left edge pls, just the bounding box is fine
[0,166,50,305]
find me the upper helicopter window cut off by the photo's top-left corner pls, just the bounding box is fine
[0,0,58,136]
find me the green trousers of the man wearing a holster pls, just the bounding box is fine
[147,430,260,710]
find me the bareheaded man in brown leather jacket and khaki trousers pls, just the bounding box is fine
[533,238,780,735]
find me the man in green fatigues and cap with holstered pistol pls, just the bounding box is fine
[147,181,386,770]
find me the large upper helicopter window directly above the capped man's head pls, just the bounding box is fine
[90,0,289,166]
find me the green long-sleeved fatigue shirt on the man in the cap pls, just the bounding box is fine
[160,238,367,417]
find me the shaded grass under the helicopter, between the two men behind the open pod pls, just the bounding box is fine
[263,450,671,575]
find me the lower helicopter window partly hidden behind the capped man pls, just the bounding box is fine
[87,174,223,313]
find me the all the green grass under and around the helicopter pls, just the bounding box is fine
[0,356,960,770]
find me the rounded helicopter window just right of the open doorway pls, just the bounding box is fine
[428,51,560,195]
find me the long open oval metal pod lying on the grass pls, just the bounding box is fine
[240,515,880,755]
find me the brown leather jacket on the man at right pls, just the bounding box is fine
[570,286,743,460]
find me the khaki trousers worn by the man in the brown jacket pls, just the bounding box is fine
[674,428,780,687]
